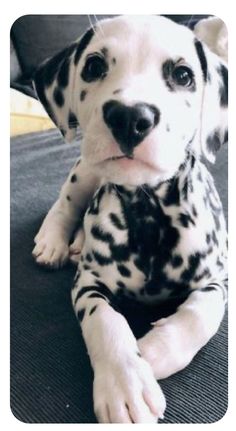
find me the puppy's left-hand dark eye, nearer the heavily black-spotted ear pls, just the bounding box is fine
[81,54,108,82]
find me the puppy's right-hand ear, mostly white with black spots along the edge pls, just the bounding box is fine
[195,40,228,163]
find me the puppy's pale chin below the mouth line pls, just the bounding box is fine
[92,156,169,186]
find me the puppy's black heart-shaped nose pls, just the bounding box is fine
[103,100,160,155]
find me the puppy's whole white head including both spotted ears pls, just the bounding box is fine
[35,16,228,185]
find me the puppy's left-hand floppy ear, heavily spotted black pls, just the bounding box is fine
[33,28,94,142]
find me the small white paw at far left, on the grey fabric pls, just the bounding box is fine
[32,231,69,268]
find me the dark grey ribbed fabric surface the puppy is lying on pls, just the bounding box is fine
[11,131,228,423]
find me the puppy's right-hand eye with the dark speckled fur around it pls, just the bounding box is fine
[162,60,196,92]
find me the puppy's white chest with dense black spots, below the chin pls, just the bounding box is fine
[83,167,227,302]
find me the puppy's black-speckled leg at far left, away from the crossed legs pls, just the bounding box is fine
[33,159,99,267]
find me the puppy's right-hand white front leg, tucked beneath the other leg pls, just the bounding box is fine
[138,283,226,379]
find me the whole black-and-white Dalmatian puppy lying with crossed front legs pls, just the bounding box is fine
[33,16,228,423]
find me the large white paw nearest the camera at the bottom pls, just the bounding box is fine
[93,354,166,423]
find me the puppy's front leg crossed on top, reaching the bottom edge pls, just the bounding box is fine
[72,271,165,423]
